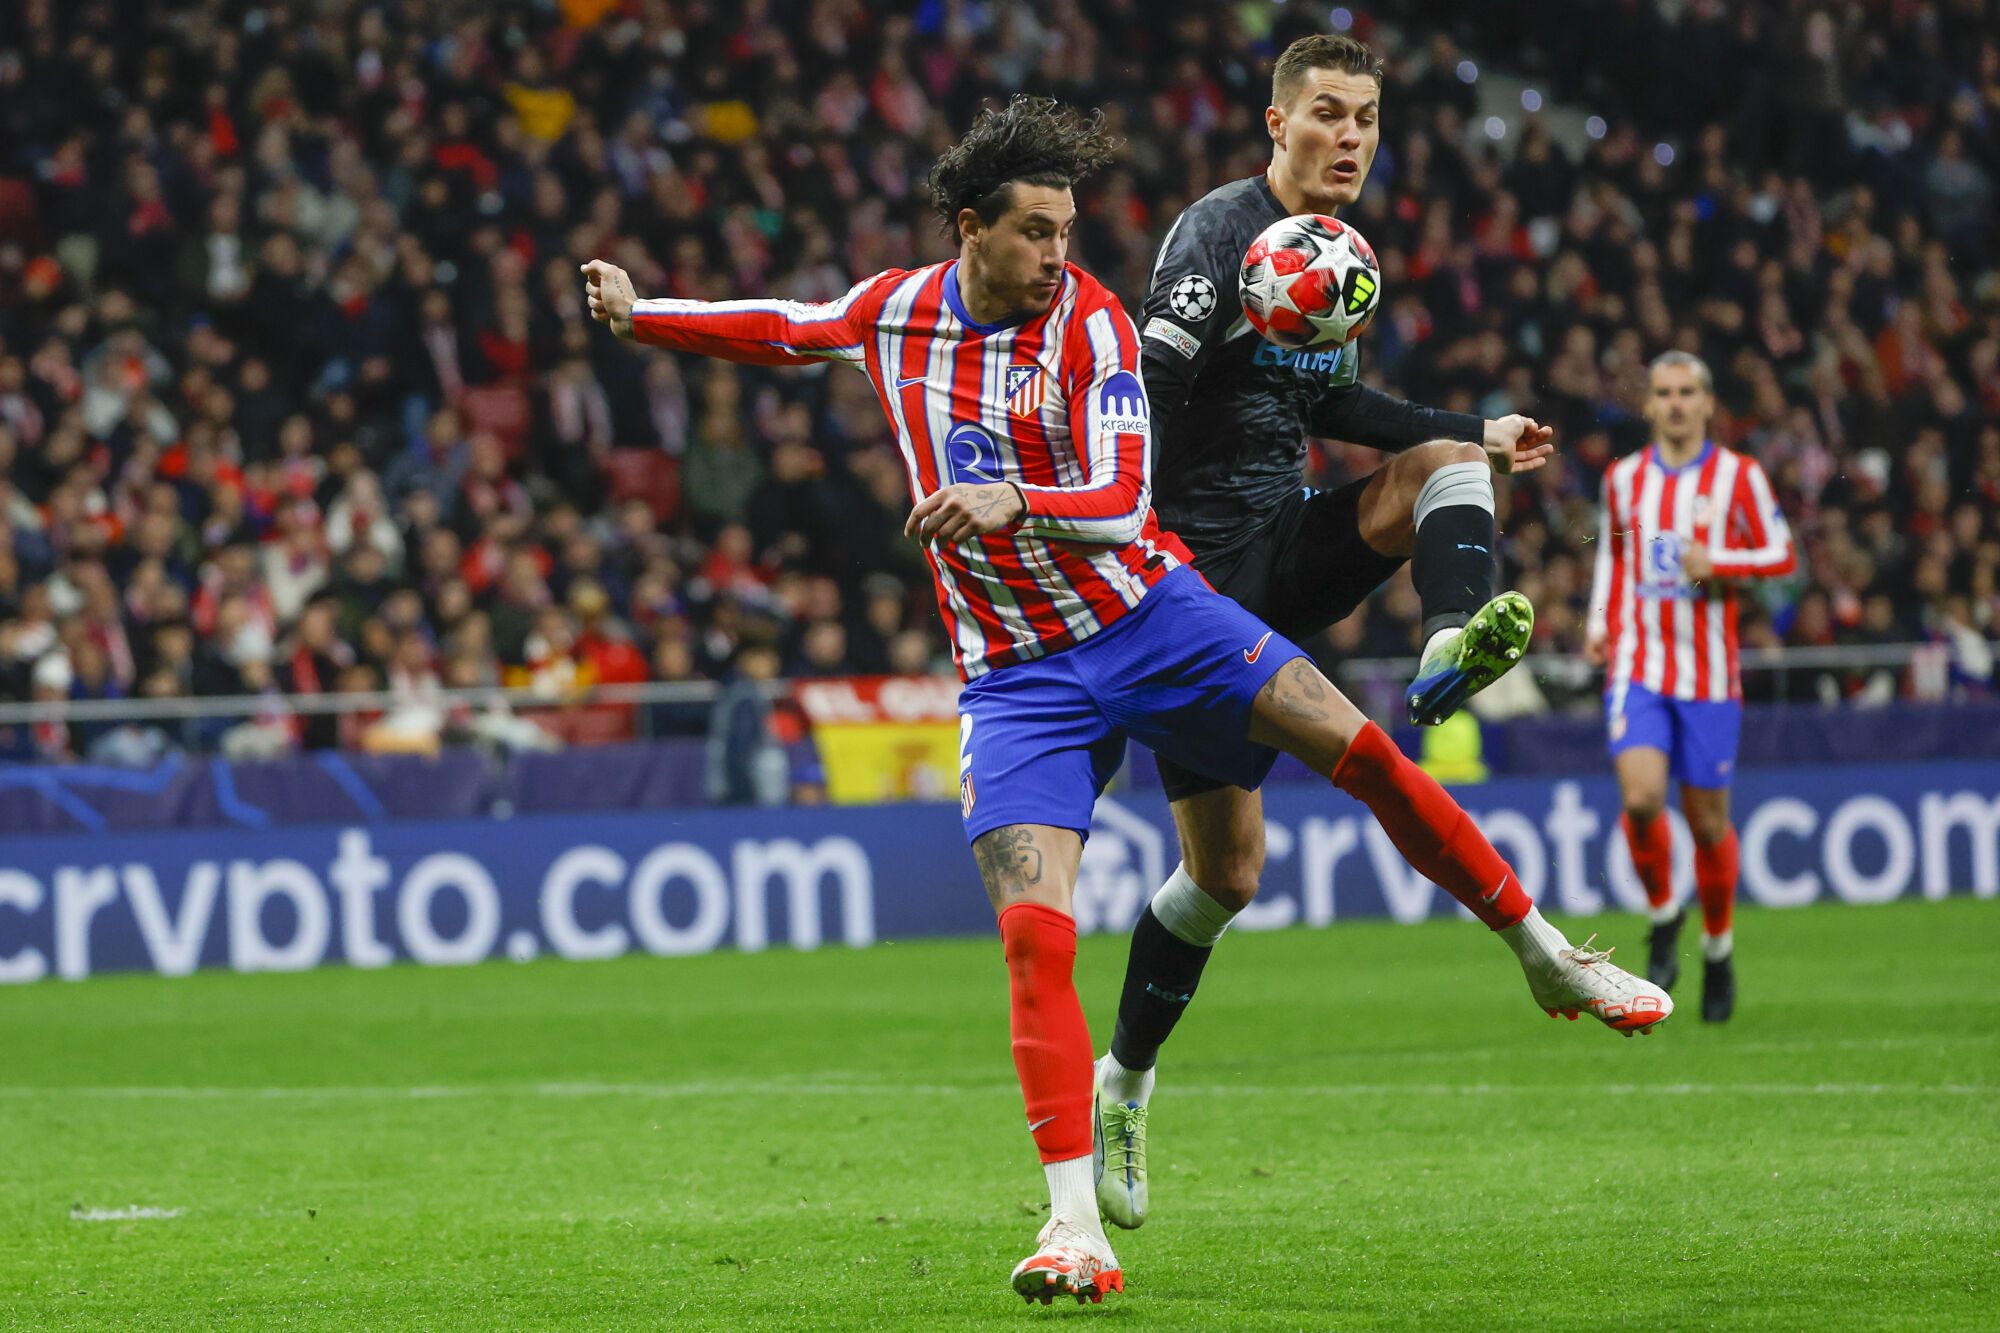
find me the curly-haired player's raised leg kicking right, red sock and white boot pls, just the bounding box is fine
[1250,656,1674,1035]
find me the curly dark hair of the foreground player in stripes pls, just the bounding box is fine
[930,92,1118,240]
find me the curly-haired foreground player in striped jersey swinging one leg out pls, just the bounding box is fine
[584,98,1672,1303]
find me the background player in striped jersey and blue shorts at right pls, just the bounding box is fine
[1584,352,1794,1023]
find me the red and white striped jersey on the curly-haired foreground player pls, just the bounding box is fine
[632,262,1190,681]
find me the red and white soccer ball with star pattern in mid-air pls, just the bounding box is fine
[1236,212,1382,348]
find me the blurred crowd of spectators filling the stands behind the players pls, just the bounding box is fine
[0,0,2000,759]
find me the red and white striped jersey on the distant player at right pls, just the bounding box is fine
[1590,442,1796,699]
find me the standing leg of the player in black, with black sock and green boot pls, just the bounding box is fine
[1096,787,1264,1229]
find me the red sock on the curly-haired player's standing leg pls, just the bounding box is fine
[1000,903,1092,1163]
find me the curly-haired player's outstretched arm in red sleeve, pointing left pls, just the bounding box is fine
[584,260,880,366]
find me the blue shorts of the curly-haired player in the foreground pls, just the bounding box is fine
[958,566,1304,843]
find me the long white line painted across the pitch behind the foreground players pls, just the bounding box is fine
[0,1081,2000,1101]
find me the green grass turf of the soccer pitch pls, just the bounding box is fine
[0,901,2000,1329]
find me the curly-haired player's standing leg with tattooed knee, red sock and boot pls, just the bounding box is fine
[972,825,1124,1305]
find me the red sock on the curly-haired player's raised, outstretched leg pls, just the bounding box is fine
[1334,723,1534,931]
